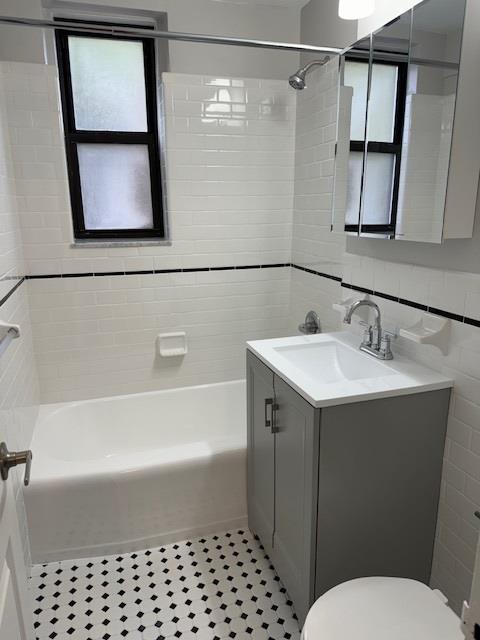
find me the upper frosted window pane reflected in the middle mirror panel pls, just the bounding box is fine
[368,64,398,142]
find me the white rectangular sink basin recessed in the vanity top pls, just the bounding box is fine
[274,340,395,384]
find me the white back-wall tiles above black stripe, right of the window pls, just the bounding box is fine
[163,73,295,268]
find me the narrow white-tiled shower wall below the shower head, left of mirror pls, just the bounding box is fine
[290,59,345,331]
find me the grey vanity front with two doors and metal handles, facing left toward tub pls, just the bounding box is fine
[247,352,320,620]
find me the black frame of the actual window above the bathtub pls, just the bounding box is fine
[55,18,165,240]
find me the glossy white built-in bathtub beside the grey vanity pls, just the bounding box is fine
[24,380,247,563]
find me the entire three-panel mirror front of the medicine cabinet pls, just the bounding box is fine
[332,0,465,243]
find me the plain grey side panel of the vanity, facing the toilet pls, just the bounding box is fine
[315,389,450,598]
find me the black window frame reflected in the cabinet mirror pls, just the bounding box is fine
[345,52,408,237]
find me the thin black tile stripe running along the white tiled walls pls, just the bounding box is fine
[0,262,480,328]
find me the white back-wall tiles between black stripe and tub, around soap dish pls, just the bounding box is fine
[28,267,290,402]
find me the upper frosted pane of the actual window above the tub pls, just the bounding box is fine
[68,36,147,131]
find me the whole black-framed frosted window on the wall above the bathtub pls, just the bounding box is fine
[56,23,164,239]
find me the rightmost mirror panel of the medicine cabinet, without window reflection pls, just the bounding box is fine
[395,0,465,243]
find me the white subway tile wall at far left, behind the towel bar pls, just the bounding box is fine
[0,63,39,565]
